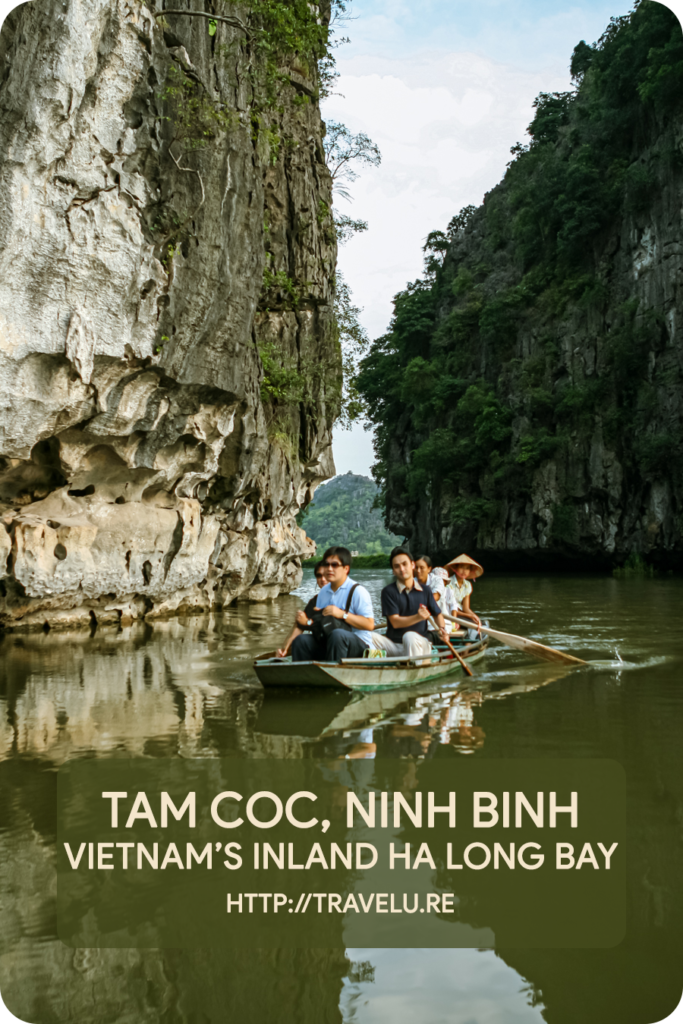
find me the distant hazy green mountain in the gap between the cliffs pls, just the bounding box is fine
[297,473,402,555]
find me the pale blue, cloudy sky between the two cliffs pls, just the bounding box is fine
[323,0,632,475]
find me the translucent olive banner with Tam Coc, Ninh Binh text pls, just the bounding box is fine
[57,759,626,948]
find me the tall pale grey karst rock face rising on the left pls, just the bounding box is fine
[0,0,341,629]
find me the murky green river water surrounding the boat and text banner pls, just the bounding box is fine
[0,570,683,1024]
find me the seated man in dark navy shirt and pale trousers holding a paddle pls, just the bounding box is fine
[372,548,446,657]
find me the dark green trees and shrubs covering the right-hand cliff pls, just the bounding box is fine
[356,0,683,569]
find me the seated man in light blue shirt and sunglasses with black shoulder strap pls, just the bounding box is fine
[292,547,375,662]
